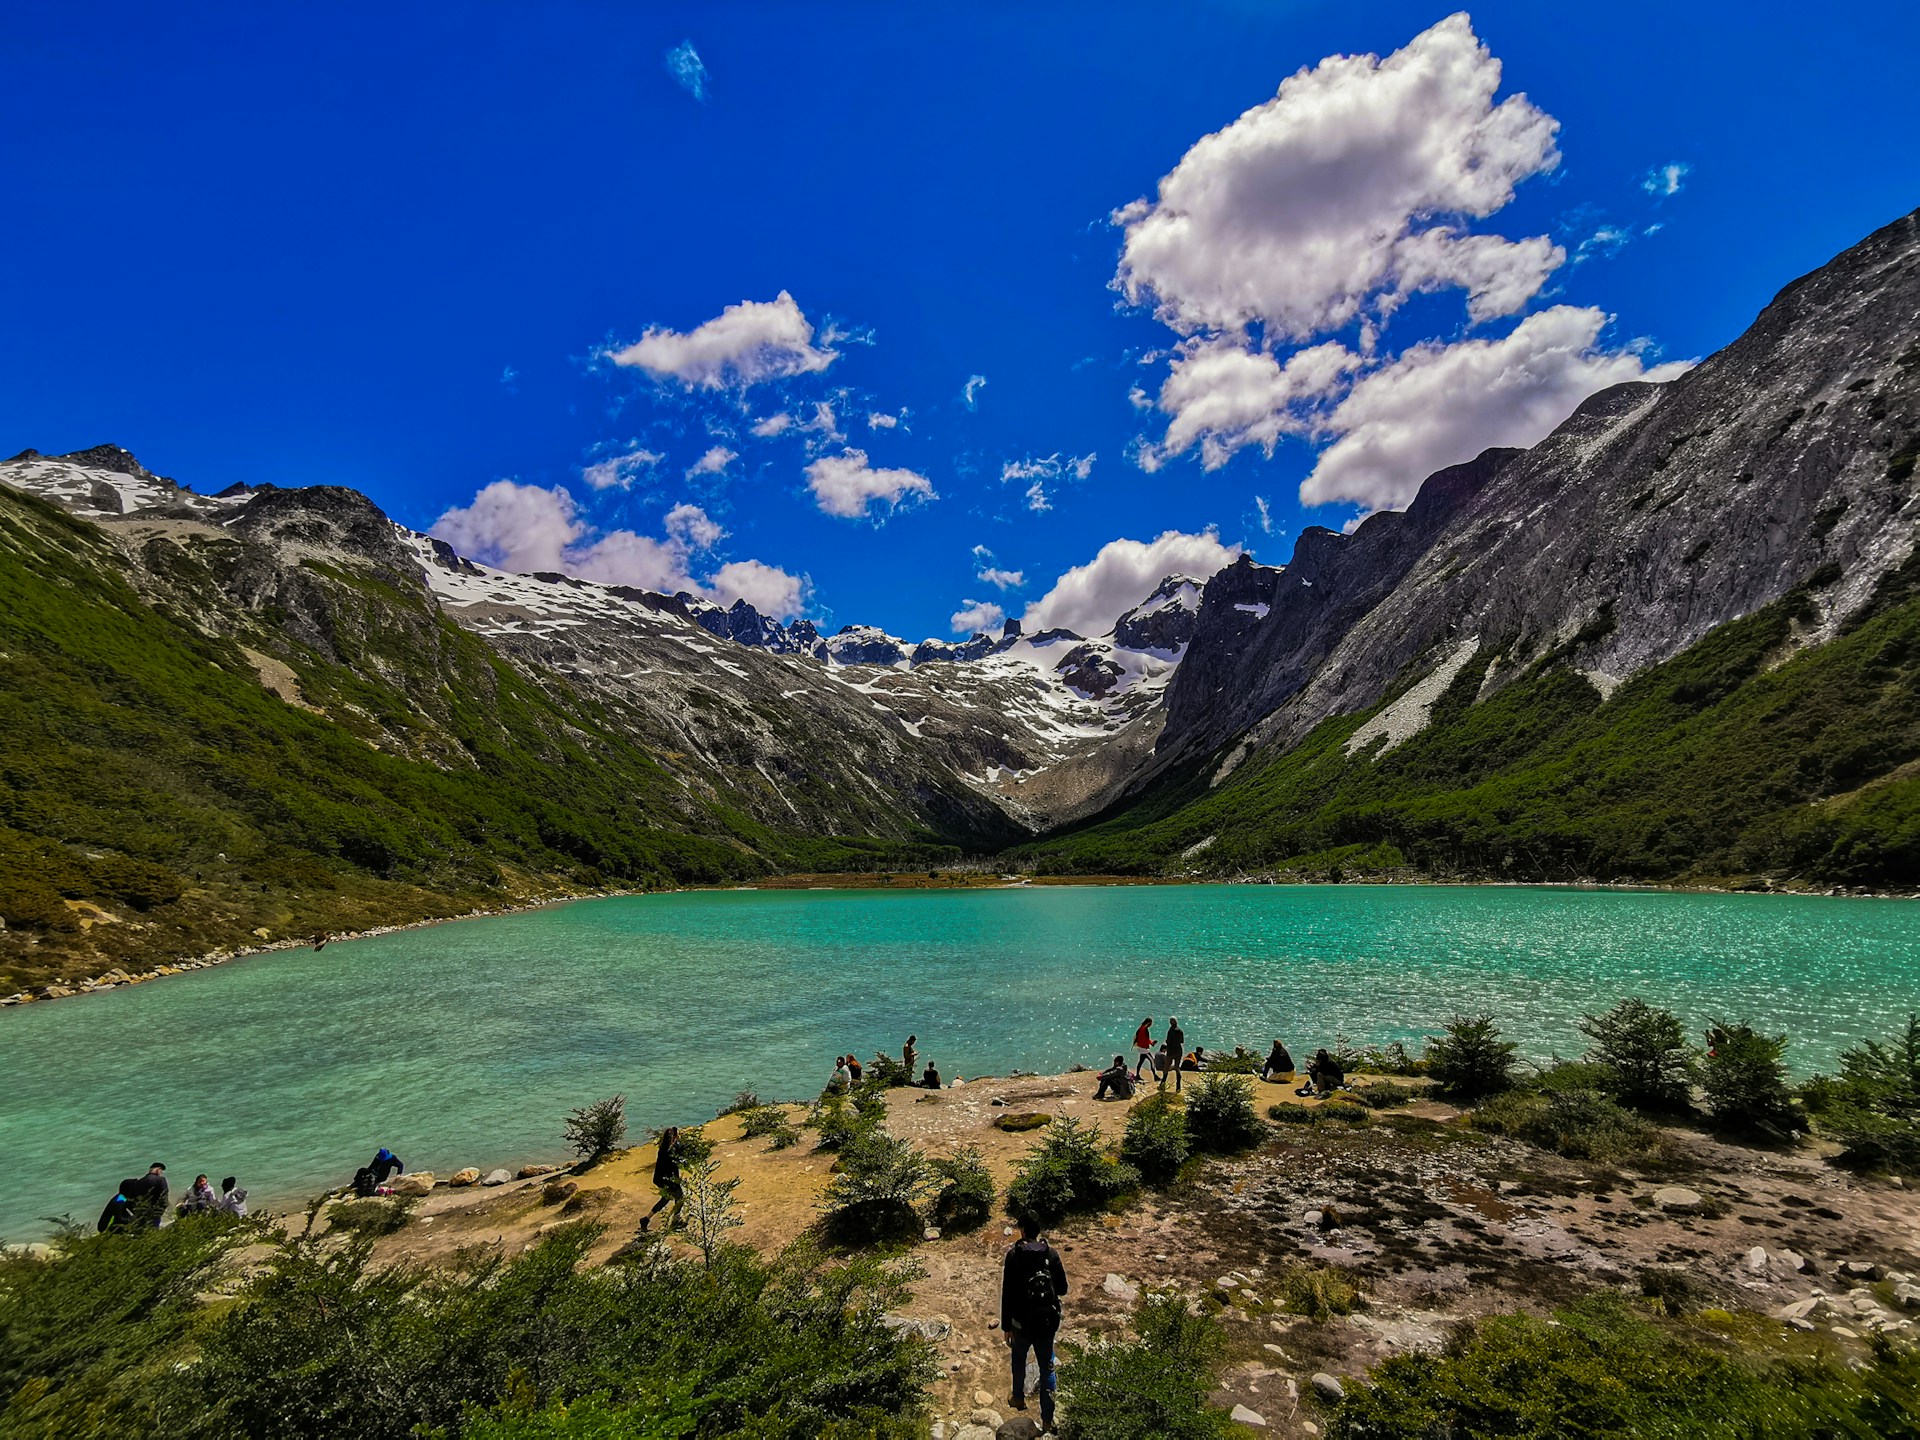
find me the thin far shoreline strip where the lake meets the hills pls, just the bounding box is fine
[0,870,1920,1010]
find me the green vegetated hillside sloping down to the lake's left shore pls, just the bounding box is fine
[0,490,954,993]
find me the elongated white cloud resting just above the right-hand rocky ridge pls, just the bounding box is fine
[1300,305,1686,511]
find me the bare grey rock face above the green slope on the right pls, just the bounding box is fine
[1158,205,1920,779]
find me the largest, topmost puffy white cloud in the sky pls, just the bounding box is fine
[1114,13,1559,338]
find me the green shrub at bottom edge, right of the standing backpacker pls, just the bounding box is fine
[1060,1296,1233,1440]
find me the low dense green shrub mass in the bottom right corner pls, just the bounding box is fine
[1327,1292,1920,1440]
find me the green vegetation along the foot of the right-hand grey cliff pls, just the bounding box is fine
[1016,561,1920,885]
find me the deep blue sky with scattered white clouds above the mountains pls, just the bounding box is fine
[0,0,1920,637]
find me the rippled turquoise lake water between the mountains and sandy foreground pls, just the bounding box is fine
[0,885,1920,1240]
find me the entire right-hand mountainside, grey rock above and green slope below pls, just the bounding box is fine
[1021,215,1920,885]
